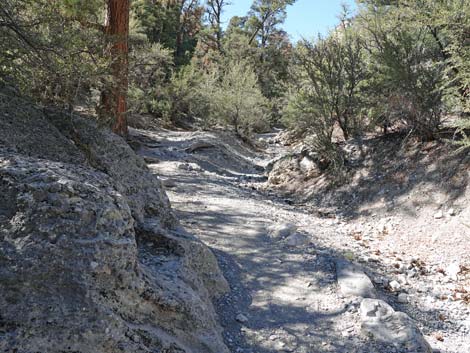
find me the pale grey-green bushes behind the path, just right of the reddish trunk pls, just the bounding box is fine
[132,55,269,137]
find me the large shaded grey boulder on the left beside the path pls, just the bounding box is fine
[0,93,228,353]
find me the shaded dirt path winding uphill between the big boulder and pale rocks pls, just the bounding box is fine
[132,131,465,353]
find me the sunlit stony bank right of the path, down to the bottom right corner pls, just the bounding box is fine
[254,134,470,353]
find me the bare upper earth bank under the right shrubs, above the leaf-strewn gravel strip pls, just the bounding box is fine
[265,134,470,268]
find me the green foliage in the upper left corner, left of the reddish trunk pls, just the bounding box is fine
[0,0,108,107]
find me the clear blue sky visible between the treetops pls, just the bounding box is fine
[224,0,355,41]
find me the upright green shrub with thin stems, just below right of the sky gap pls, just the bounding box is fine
[285,29,366,168]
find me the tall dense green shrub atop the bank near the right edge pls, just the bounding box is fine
[360,1,444,139]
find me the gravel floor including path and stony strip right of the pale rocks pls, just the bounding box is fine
[133,131,470,353]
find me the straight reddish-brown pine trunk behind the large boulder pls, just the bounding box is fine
[101,0,129,136]
